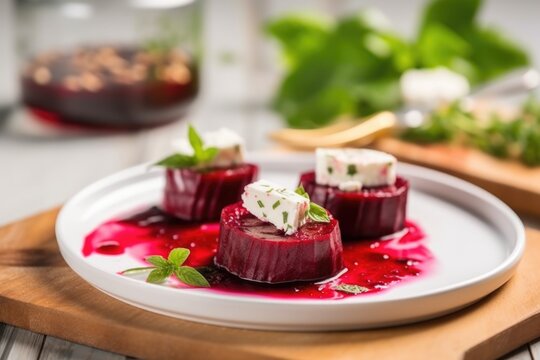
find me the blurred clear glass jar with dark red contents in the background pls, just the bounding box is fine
[16,0,201,129]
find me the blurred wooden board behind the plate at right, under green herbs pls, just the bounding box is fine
[373,138,540,218]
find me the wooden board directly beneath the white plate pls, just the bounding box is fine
[0,210,540,359]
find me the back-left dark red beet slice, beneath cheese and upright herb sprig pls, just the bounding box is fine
[163,164,258,221]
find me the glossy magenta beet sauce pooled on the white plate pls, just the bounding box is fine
[82,207,433,299]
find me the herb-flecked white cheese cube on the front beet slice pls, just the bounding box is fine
[242,180,309,235]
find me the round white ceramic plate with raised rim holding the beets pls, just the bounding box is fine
[56,155,525,331]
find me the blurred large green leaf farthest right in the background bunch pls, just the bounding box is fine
[417,0,529,84]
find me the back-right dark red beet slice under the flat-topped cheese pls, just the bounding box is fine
[300,171,409,240]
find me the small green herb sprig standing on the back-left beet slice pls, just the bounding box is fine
[155,125,218,169]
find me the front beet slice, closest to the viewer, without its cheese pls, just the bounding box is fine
[215,202,343,283]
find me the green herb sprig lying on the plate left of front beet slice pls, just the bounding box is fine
[121,248,210,287]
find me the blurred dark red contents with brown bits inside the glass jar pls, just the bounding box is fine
[21,46,199,129]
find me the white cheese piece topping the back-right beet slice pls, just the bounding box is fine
[315,148,397,191]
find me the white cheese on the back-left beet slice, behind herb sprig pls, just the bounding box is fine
[173,128,245,167]
